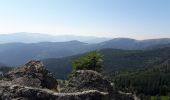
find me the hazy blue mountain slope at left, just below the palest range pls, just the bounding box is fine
[0,41,89,65]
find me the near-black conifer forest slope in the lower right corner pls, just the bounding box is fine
[113,59,170,97]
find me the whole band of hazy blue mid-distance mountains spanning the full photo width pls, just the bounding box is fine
[0,38,170,66]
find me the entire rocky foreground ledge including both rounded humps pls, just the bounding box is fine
[0,61,132,100]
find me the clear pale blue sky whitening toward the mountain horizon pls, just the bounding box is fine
[0,0,170,39]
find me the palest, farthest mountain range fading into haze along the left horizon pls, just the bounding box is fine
[0,32,109,43]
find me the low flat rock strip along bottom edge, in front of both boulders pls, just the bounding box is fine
[0,82,109,100]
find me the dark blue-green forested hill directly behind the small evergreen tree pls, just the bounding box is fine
[43,47,170,79]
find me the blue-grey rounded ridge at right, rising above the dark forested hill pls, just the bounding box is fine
[98,38,170,50]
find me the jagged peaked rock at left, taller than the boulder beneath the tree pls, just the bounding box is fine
[3,61,57,90]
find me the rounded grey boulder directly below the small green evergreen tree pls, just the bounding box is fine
[63,70,113,93]
